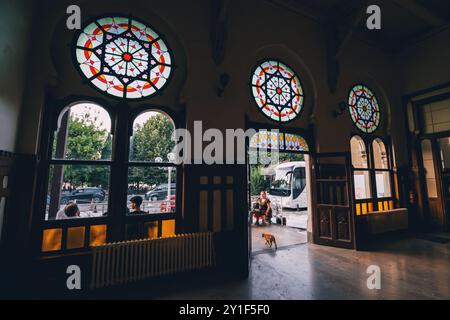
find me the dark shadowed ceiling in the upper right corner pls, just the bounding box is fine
[271,0,450,52]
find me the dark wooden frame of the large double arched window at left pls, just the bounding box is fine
[31,95,184,257]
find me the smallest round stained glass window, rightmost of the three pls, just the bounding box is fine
[348,85,380,133]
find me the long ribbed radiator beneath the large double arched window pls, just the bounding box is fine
[91,232,215,289]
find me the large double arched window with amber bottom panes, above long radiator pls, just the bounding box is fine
[39,102,180,252]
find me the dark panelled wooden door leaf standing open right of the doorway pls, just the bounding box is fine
[312,153,355,249]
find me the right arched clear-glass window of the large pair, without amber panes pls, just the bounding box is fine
[128,111,177,218]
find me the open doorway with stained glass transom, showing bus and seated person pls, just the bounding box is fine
[248,131,311,254]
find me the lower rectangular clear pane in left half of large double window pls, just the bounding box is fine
[45,165,110,220]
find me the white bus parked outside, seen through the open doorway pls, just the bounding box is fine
[267,161,308,210]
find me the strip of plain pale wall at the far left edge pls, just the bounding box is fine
[0,0,31,151]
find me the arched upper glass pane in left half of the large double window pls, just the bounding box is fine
[52,103,112,160]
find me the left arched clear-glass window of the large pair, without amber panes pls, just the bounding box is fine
[46,102,112,220]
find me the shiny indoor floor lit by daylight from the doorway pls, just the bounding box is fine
[158,238,450,299]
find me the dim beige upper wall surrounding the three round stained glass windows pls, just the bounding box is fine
[17,0,450,172]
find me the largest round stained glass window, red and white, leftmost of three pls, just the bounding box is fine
[75,17,172,99]
